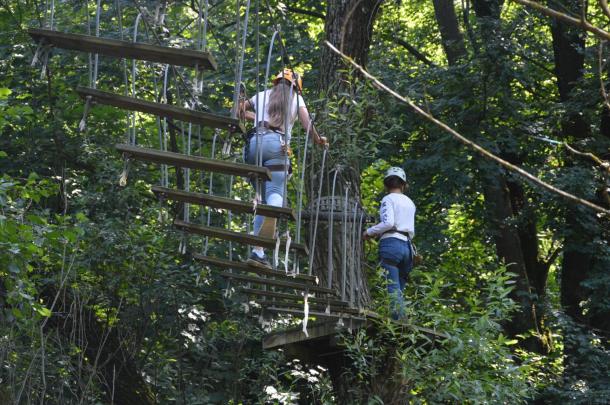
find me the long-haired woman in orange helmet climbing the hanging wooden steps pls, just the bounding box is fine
[240,69,328,268]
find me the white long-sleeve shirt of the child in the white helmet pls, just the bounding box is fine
[366,193,415,240]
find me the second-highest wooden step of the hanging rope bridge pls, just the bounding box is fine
[76,87,246,133]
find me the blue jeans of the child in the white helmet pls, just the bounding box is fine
[379,238,413,319]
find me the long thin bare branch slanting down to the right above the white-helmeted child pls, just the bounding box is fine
[324,40,610,215]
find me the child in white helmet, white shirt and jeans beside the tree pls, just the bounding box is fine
[363,167,415,320]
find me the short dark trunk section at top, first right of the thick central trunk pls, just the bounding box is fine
[432,0,466,66]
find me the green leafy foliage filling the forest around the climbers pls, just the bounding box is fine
[0,0,610,404]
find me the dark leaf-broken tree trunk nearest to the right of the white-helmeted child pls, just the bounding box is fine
[473,0,546,353]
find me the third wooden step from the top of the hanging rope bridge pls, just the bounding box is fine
[116,144,271,180]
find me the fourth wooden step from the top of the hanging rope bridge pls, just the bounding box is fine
[152,186,296,220]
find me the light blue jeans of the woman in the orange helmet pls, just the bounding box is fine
[245,131,288,235]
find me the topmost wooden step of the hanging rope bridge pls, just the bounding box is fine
[28,28,218,70]
